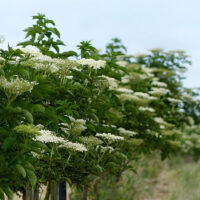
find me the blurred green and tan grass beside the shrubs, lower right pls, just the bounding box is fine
[86,155,200,200]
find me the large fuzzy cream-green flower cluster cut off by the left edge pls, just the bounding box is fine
[0,76,38,96]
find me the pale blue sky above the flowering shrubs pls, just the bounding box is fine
[0,0,200,88]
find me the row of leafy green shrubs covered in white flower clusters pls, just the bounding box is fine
[0,14,199,199]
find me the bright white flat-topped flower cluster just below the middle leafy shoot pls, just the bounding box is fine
[76,58,106,69]
